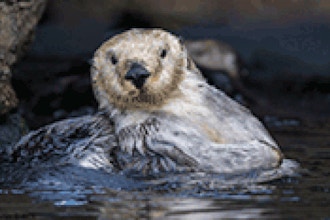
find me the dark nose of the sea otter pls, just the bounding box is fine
[125,63,150,89]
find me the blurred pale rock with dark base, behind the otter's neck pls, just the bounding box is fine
[184,39,252,105]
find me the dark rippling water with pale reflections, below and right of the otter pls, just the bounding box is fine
[0,121,330,219]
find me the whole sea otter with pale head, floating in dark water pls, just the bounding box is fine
[8,29,283,179]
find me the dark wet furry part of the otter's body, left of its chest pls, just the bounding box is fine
[8,114,114,161]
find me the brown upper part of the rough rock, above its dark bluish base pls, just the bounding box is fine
[0,0,47,114]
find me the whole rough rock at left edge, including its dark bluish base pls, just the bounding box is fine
[0,0,47,152]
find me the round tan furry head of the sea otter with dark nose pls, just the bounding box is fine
[92,29,187,110]
